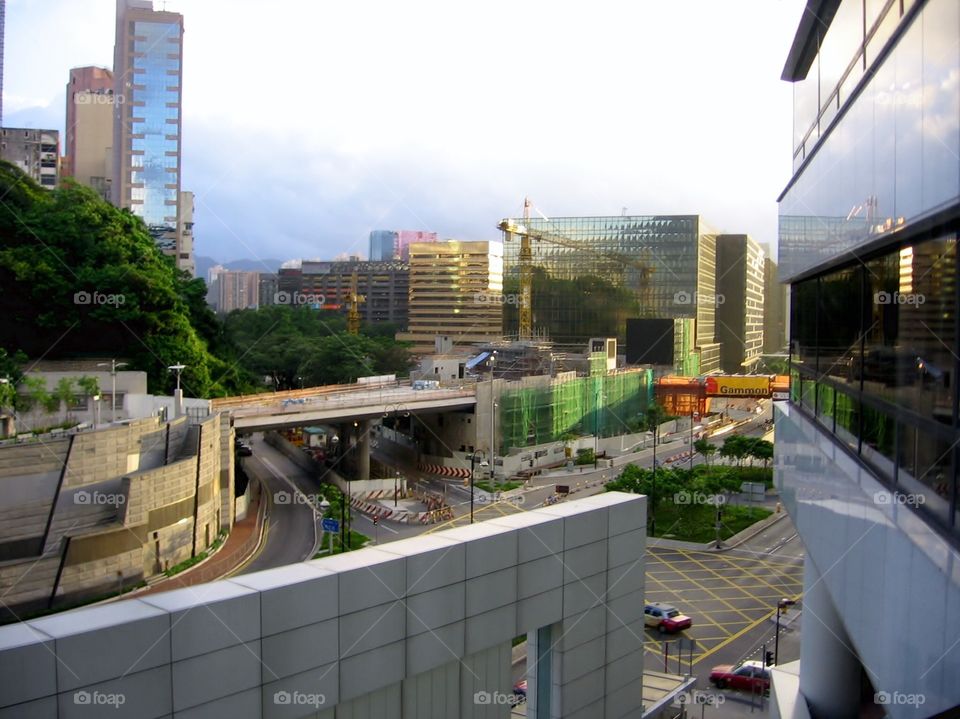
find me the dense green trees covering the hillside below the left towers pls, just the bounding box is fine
[0,163,255,397]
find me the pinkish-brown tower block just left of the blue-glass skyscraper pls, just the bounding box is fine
[61,66,114,193]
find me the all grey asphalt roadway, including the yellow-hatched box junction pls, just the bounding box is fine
[243,406,803,719]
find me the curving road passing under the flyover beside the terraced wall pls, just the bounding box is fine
[234,435,318,574]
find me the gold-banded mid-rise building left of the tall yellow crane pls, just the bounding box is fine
[397,240,504,354]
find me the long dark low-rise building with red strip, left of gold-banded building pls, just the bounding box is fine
[300,260,410,329]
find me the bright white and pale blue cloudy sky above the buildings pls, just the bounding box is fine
[3,0,804,271]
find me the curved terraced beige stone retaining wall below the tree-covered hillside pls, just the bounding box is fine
[0,415,232,619]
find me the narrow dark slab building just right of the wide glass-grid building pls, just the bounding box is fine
[717,235,764,374]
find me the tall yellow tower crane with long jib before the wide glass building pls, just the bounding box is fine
[497,198,653,340]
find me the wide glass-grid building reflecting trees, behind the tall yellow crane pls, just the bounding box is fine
[504,215,720,372]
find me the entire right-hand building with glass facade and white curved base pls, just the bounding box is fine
[771,0,960,719]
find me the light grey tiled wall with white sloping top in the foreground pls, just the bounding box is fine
[0,492,652,719]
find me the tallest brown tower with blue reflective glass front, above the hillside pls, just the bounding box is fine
[111,0,186,267]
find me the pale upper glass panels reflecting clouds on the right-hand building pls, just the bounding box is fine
[780,0,960,279]
